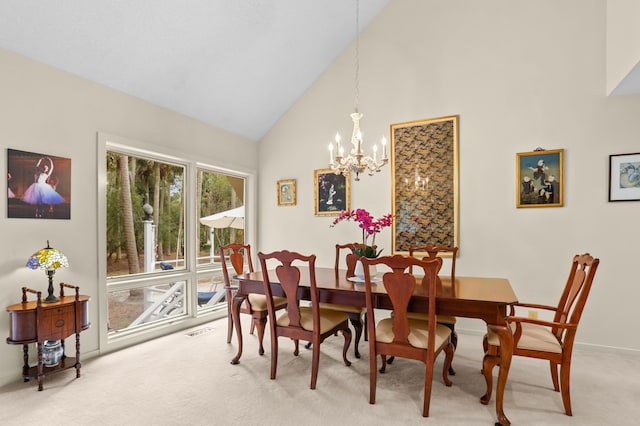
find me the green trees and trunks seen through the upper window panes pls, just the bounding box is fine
[106,151,244,276]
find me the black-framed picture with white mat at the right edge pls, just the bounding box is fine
[609,153,640,201]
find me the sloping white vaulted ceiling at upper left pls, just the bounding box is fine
[0,0,389,140]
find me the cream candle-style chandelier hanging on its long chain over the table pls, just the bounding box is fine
[329,0,389,181]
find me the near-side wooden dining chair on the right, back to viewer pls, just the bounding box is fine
[361,255,455,417]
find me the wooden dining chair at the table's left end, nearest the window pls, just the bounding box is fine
[219,243,287,355]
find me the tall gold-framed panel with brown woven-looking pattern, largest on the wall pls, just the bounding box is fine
[391,115,459,254]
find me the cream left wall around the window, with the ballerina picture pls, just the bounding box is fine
[0,49,257,384]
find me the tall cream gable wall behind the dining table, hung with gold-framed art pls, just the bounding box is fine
[259,0,640,350]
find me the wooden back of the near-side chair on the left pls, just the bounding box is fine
[258,250,320,330]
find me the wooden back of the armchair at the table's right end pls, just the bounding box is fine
[553,253,600,340]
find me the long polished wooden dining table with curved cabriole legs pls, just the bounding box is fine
[231,267,518,425]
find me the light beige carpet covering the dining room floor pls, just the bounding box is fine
[0,315,640,425]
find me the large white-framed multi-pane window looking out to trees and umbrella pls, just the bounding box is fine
[99,135,247,346]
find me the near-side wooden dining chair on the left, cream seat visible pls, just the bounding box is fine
[258,250,351,389]
